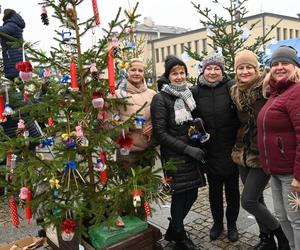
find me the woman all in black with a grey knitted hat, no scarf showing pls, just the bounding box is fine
[192,53,240,242]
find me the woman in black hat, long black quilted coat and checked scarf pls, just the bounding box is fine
[151,56,205,250]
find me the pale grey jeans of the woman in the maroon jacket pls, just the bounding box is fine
[271,175,300,250]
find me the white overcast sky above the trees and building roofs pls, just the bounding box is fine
[0,0,300,50]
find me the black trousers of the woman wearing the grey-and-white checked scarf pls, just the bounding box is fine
[171,188,198,232]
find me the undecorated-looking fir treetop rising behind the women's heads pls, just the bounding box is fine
[186,0,279,72]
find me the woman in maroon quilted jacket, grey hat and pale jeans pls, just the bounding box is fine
[257,46,300,250]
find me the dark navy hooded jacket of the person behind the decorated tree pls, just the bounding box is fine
[0,13,25,80]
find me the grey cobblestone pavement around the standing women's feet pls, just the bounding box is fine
[150,183,273,250]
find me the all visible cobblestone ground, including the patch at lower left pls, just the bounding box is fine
[0,181,273,250]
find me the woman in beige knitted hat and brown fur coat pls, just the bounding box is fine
[231,50,289,250]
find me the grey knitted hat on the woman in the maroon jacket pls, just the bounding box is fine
[271,45,300,67]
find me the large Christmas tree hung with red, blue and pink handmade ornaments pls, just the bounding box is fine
[0,0,163,244]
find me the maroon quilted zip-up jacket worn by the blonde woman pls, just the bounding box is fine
[257,80,300,180]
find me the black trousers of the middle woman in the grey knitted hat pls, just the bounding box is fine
[207,173,240,227]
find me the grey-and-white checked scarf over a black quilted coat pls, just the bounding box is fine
[161,83,196,125]
